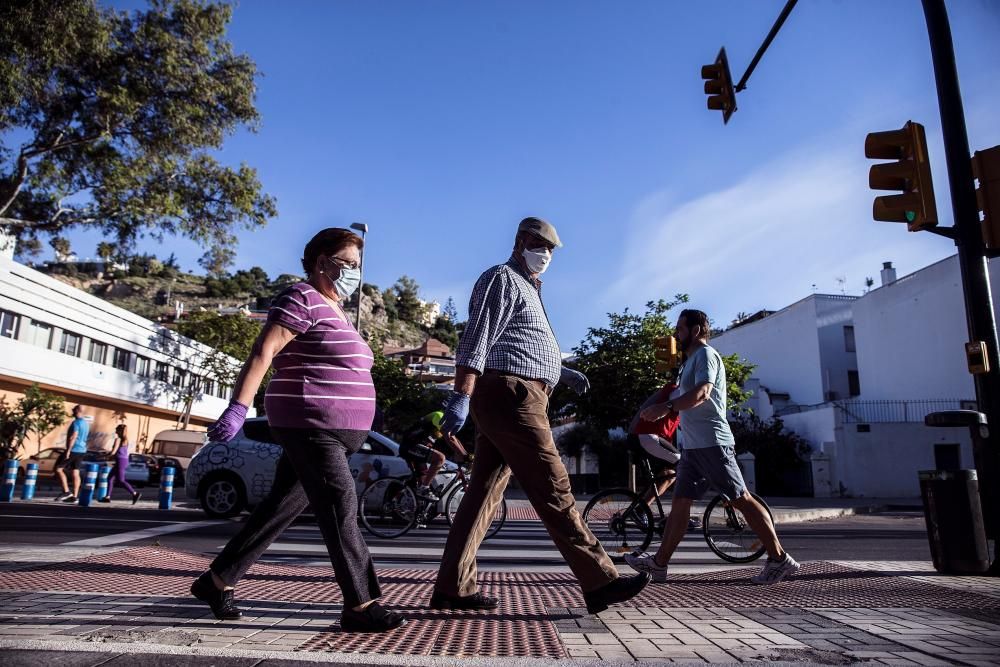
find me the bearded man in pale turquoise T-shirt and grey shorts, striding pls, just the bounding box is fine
[625,309,799,584]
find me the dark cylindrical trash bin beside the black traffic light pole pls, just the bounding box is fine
[918,470,990,574]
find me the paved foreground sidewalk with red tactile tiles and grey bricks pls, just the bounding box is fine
[0,547,1000,665]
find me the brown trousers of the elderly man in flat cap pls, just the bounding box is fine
[435,373,618,597]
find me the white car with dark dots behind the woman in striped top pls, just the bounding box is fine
[185,417,455,517]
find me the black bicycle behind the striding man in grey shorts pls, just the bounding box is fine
[583,448,774,563]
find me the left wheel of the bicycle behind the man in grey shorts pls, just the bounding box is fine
[583,489,653,556]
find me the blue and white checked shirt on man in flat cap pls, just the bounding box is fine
[455,256,562,387]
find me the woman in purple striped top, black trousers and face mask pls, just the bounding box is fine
[191,228,404,632]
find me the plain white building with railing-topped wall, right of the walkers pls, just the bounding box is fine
[712,256,1000,497]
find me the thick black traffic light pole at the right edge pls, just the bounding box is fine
[922,0,1000,574]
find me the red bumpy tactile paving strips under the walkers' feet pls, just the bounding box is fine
[0,547,1000,658]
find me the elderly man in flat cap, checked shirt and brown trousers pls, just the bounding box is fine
[431,218,650,614]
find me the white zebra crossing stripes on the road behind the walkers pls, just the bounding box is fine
[240,519,745,573]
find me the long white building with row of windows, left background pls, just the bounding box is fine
[0,253,239,455]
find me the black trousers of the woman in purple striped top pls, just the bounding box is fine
[211,427,382,607]
